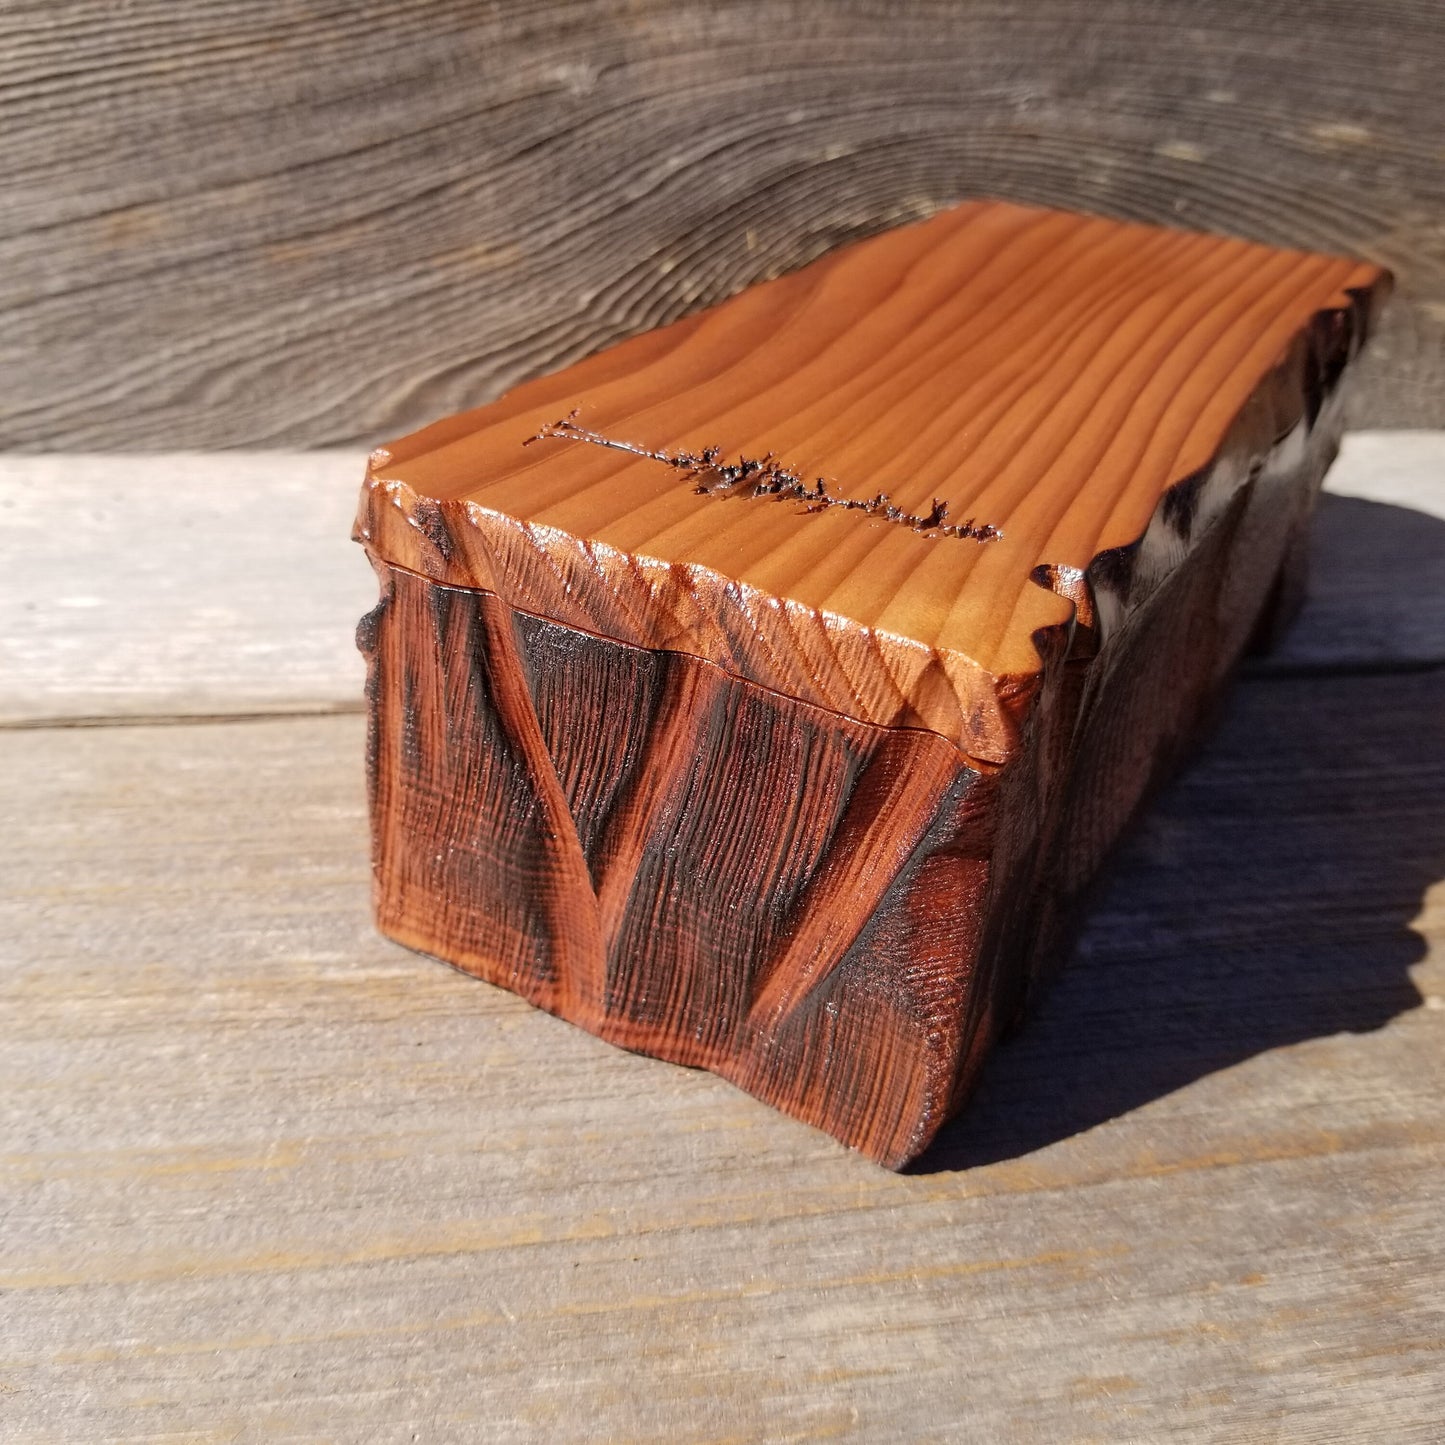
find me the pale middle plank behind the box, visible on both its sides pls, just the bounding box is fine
[0,432,1445,723]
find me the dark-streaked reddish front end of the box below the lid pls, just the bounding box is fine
[363,569,991,1165]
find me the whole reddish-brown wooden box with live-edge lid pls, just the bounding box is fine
[346,197,1386,1168]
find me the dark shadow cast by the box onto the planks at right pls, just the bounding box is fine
[913,497,1445,1173]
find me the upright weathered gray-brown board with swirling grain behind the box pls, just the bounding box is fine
[0,0,1445,451]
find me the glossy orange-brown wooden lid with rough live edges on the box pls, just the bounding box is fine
[349,202,1389,762]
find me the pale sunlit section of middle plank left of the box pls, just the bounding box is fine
[0,452,376,723]
